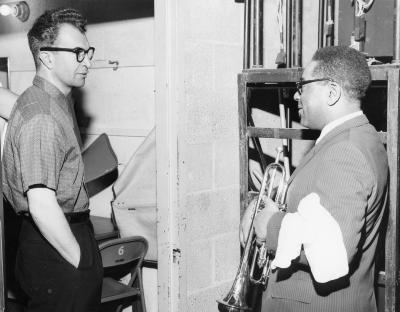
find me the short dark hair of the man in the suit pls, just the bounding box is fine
[312,46,371,100]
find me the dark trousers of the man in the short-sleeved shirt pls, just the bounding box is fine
[15,213,103,312]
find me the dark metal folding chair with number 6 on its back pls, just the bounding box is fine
[99,236,148,312]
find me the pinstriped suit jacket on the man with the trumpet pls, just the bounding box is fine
[262,115,388,312]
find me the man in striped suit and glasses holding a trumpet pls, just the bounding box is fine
[241,46,388,312]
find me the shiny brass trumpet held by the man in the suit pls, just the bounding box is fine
[217,148,289,312]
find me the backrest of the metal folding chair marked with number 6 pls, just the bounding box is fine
[99,236,148,285]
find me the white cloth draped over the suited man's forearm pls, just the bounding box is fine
[271,193,349,283]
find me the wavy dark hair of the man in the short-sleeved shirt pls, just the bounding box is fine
[28,8,87,68]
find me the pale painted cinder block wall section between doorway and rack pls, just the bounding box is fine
[179,0,243,312]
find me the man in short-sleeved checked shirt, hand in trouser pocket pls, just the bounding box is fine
[3,9,103,312]
